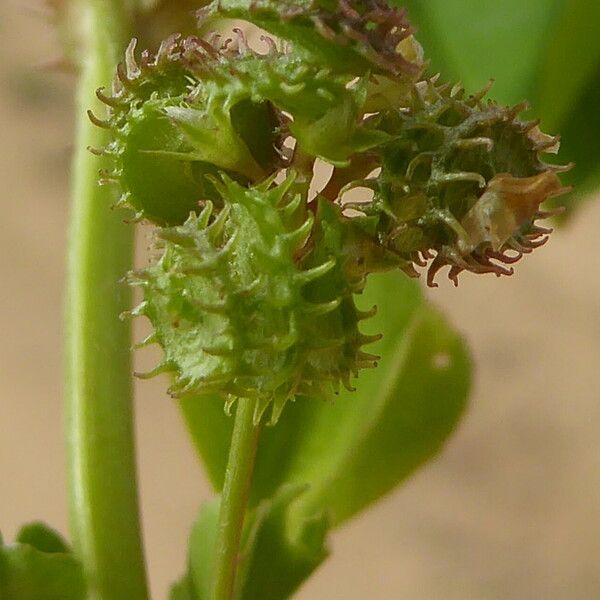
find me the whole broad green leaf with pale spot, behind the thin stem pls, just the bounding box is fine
[183,273,470,523]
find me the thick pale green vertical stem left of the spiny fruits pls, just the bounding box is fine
[65,0,148,600]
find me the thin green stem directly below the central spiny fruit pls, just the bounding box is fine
[212,399,260,600]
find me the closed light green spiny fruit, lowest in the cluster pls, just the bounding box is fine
[130,177,374,421]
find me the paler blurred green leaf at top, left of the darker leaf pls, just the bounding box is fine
[391,0,565,103]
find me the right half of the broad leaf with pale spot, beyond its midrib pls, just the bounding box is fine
[294,309,469,524]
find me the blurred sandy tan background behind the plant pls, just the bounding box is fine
[0,0,600,600]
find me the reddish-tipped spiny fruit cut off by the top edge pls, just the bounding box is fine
[198,0,420,76]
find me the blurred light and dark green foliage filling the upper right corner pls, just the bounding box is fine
[392,0,600,216]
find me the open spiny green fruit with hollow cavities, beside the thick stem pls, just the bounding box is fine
[90,32,388,225]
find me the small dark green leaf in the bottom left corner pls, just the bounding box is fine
[0,523,85,600]
